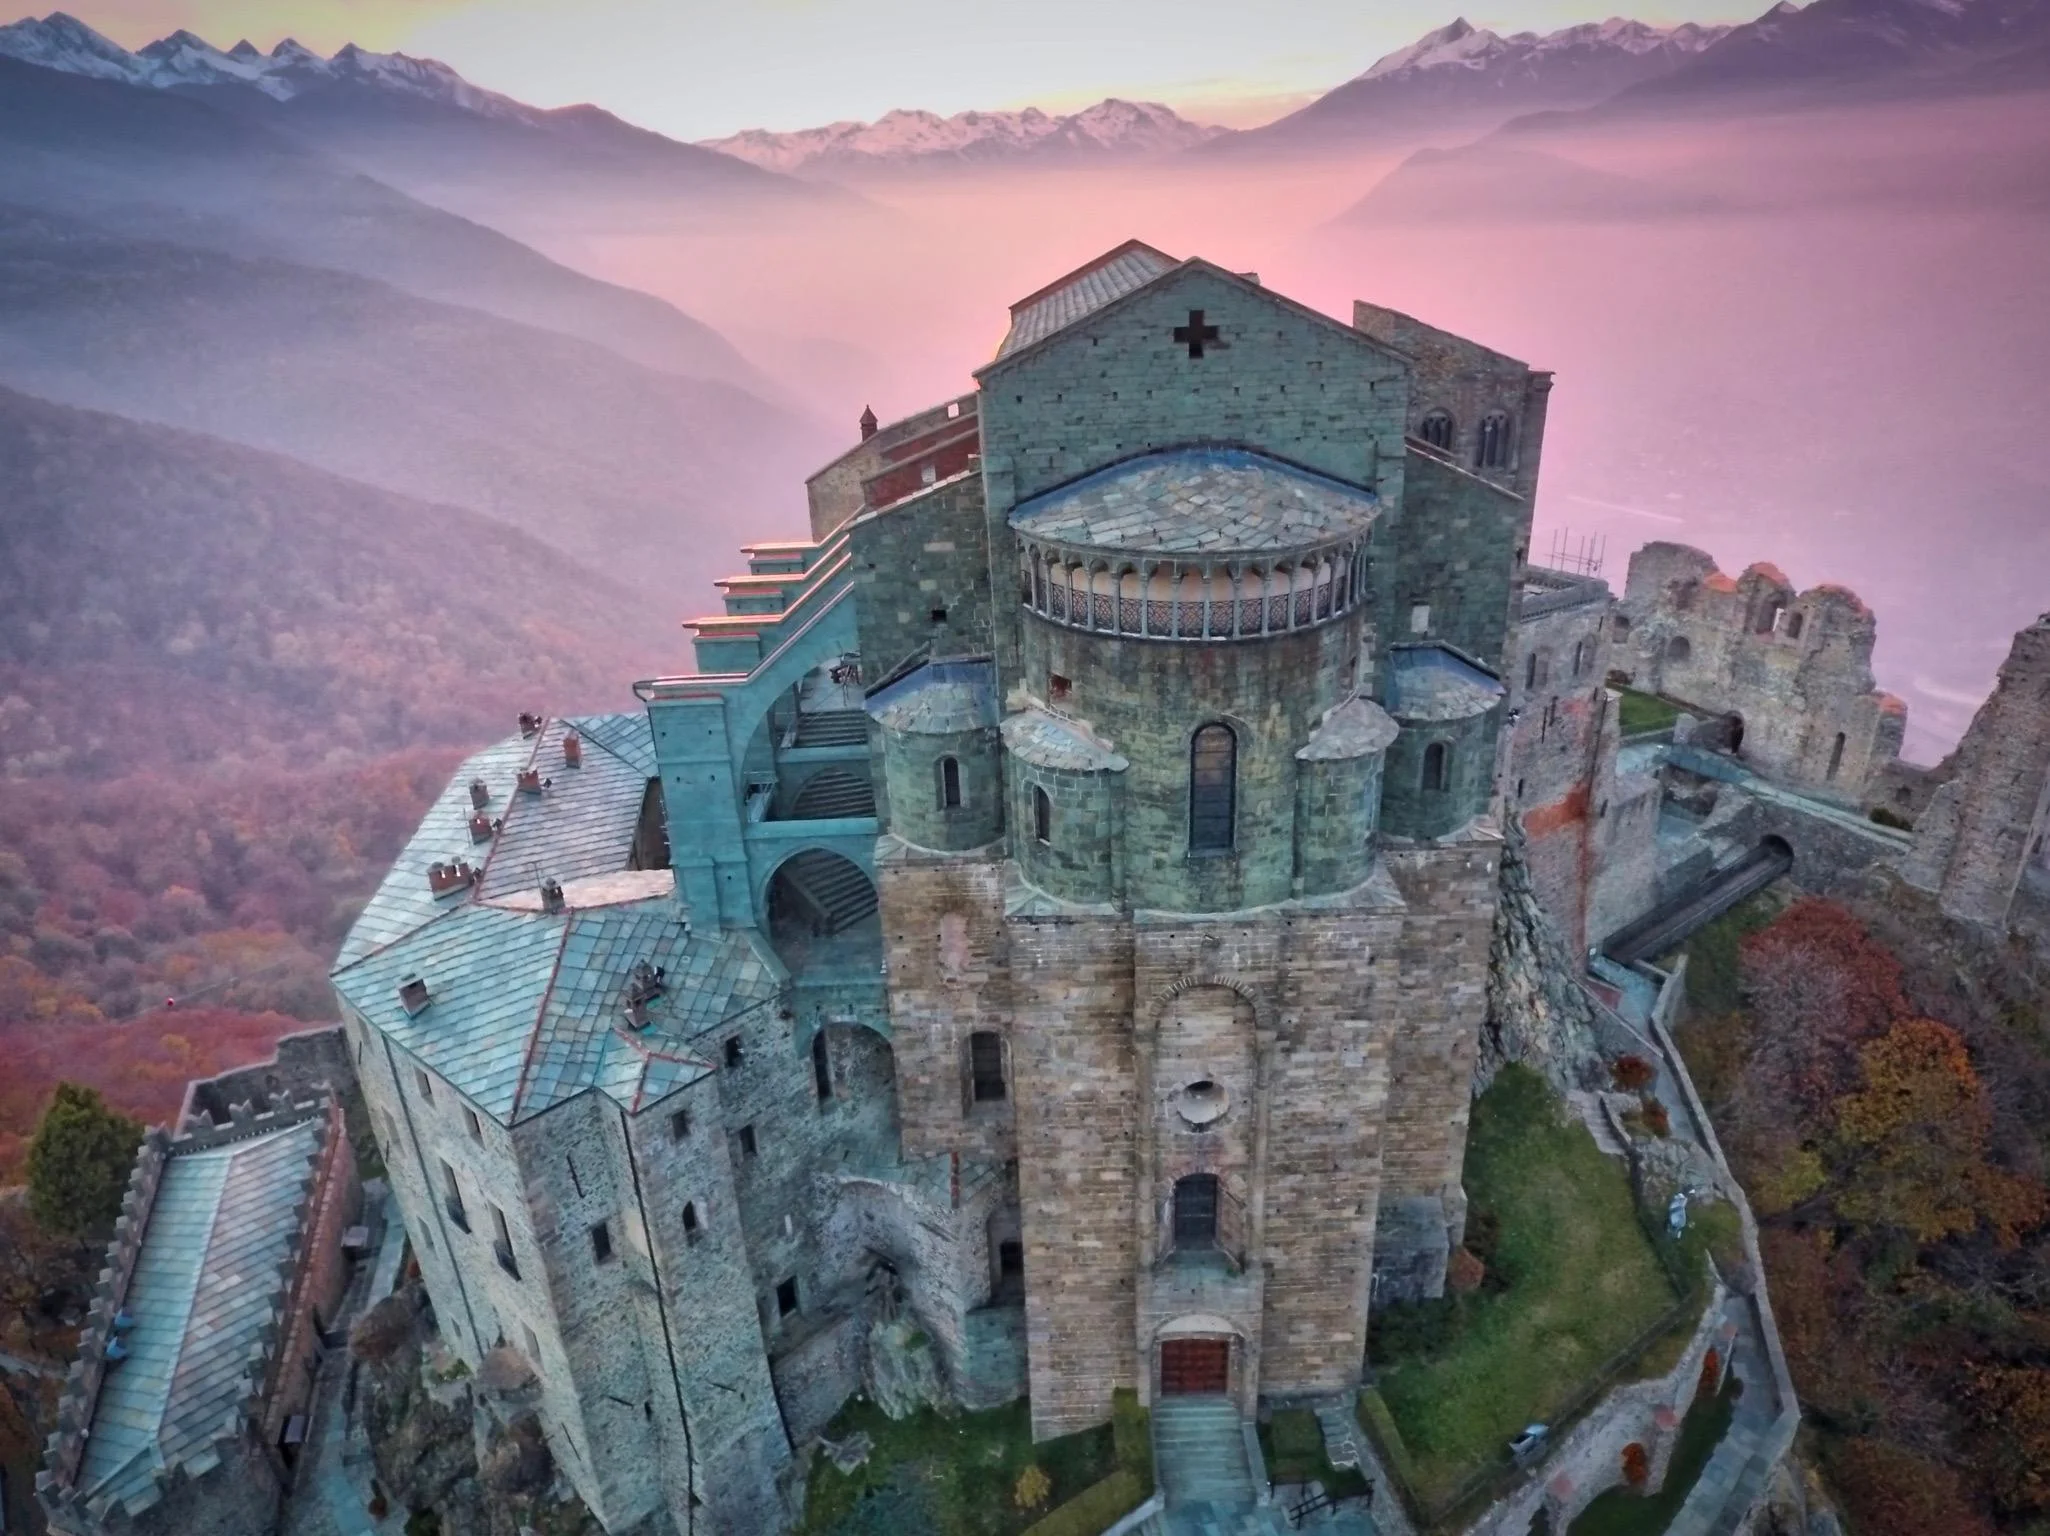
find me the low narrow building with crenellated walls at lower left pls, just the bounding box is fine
[37,1093,361,1536]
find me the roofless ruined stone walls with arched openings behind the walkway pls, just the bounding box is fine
[1615,543,1907,806]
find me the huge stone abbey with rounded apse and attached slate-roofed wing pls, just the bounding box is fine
[334,242,1541,1532]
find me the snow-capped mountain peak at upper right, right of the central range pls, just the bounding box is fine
[1232,16,1730,148]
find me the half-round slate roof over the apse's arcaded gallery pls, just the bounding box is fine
[1011,447,1380,556]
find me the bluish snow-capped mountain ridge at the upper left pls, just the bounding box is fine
[0,10,541,121]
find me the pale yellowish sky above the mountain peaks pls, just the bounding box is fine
[39,0,1763,139]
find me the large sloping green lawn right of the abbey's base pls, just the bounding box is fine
[1369,1066,1677,1509]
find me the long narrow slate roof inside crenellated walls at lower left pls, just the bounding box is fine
[78,1116,322,1507]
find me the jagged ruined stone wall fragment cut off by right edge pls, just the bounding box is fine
[1902,613,2050,931]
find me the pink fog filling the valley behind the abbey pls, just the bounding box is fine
[483,94,2050,761]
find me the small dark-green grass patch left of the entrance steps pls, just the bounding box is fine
[797,1399,1115,1536]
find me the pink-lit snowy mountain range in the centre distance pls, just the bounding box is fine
[701,96,1226,174]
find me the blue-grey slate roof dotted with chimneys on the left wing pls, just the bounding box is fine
[332,716,781,1126]
